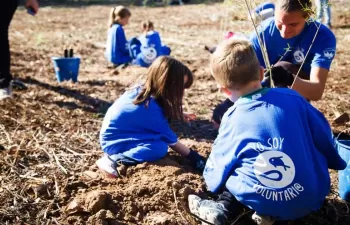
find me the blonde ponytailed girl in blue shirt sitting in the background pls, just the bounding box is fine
[106,6,132,66]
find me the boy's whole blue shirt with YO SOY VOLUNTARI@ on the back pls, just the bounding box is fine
[203,88,346,220]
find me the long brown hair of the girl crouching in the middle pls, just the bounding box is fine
[133,56,193,120]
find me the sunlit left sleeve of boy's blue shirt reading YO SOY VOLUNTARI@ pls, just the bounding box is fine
[203,114,237,193]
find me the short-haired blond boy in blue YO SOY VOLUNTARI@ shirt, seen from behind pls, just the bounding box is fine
[188,38,346,225]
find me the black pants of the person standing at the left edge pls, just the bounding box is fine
[0,0,18,88]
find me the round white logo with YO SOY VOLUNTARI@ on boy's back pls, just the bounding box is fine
[253,138,304,201]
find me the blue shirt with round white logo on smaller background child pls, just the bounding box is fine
[136,31,169,67]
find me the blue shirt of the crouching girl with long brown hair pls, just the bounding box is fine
[100,86,177,162]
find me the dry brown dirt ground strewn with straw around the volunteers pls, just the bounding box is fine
[0,0,350,225]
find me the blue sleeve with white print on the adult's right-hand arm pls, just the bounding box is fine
[311,33,336,70]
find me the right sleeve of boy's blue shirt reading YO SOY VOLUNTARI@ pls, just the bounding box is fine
[305,102,346,170]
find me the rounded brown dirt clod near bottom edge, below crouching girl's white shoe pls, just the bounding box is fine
[85,191,111,213]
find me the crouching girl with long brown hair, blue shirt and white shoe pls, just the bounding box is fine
[96,56,205,176]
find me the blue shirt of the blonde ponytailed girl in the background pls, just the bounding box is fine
[106,24,131,65]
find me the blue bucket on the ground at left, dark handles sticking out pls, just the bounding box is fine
[52,57,80,82]
